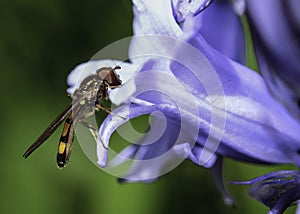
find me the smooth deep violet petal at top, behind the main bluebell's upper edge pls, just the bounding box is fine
[194,1,245,64]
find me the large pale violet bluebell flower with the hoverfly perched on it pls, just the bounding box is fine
[69,0,300,207]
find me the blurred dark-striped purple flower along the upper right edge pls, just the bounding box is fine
[247,0,300,119]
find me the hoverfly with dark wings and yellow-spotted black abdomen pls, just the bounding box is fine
[23,66,122,168]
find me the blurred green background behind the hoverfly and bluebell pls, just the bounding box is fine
[0,0,295,214]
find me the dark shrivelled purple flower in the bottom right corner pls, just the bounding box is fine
[232,170,300,214]
